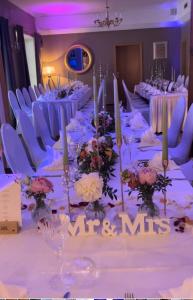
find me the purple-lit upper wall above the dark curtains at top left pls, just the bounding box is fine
[0,0,36,35]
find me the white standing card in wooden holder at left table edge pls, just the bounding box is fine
[0,174,22,233]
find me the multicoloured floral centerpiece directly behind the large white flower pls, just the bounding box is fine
[77,137,118,199]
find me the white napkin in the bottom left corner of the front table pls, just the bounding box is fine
[0,281,28,298]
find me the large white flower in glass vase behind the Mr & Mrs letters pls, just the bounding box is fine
[75,172,105,220]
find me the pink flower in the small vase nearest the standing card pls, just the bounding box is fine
[30,177,53,194]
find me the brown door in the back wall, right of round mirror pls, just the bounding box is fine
[116,44,142,104]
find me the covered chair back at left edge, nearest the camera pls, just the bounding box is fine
[1,123,35,176]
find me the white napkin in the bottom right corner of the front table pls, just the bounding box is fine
[159,277,193,299]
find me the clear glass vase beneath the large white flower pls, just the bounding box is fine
[85,200,105,221]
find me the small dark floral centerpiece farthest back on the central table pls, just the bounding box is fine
[92,111,115,136]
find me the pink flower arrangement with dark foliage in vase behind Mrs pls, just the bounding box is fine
[122,166,171,217]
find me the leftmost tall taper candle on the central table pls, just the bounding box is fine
[60,105,68,166]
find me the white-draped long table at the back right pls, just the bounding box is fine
[135,83,188,133]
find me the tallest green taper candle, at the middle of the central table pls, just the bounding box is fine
[113,76,122,147]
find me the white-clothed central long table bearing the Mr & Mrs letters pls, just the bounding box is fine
[0,101,193,298]
